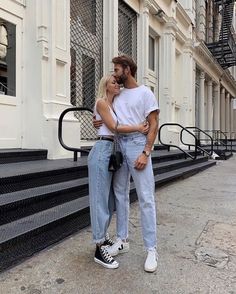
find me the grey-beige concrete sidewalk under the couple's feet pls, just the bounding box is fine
[0,156,236,294]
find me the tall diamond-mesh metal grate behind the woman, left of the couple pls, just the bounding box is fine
[70,0,103,140]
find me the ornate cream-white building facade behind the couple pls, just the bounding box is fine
[0,0,236,158]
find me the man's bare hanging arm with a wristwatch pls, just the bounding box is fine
[135,109,160,170]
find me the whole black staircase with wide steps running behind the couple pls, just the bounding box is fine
[0,146,216,271]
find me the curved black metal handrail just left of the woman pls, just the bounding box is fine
[58,107,93,161]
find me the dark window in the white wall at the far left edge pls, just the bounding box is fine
[0,18,16,96]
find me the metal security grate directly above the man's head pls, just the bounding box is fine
[118,0,137,60]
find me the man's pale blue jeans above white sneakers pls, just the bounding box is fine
[113,133,157,249]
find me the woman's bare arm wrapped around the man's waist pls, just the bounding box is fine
[96,99,149,133]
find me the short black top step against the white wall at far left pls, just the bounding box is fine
[0,149,48,164]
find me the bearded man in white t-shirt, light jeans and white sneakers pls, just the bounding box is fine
[94,55,159,272]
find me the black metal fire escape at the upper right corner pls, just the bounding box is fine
[207,0,236,69]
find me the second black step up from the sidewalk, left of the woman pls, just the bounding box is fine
[0,178,88,225]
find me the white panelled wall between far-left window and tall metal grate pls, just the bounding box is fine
[0,0,80,158]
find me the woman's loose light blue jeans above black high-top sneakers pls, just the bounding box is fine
[88,140,114,243]
